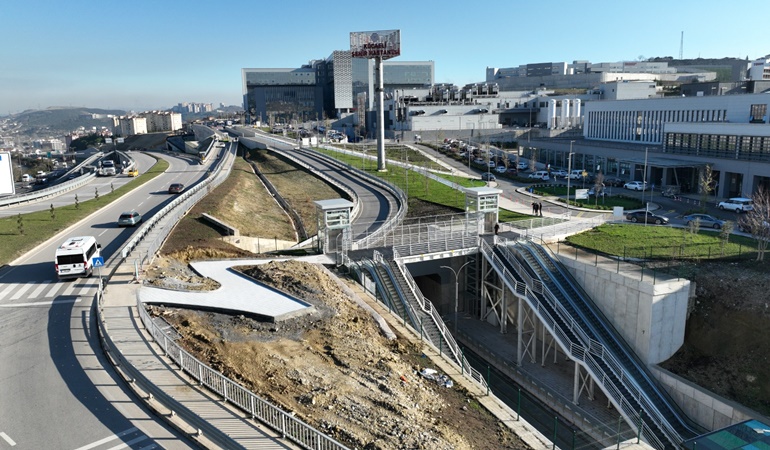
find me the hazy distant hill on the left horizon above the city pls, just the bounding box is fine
[8,107,126,137]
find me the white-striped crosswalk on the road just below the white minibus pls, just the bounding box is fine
[0,277,99,306]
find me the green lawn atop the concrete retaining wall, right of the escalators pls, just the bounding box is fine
[566,224,756,260]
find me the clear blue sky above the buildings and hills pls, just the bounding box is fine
[0,0,770,115]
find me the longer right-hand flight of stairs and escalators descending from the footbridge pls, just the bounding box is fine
[482,237,697,448]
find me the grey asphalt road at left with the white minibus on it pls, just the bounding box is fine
[0,150,213,450]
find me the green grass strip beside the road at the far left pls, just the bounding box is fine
[0,159,168,265]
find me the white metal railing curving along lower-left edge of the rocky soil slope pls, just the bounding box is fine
[137,300,347,450]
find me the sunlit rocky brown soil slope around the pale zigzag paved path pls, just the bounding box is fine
[147,261,529,450]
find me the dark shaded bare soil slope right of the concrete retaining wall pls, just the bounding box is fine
[661,260,770,415]
